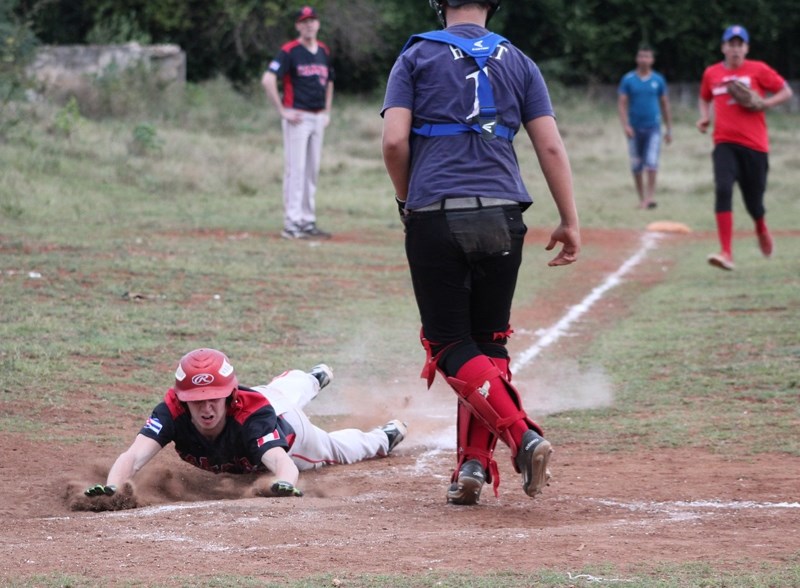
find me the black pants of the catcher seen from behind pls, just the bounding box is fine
[406,205,527,376]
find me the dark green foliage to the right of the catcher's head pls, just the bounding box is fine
[498,0,800,84]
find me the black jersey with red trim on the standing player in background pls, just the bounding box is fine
[267,39,334,111]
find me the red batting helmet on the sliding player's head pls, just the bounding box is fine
[175,349,239,402]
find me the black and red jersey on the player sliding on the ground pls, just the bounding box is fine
[139,386,295,474]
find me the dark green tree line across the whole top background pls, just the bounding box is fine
[6,0,800,93]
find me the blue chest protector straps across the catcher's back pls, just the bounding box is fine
[401,31,518,141]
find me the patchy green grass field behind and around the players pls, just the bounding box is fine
[0,82,800,587]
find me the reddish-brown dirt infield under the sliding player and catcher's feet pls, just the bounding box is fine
[0,231,800,585]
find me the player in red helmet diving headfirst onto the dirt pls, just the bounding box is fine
[84,349,407,504]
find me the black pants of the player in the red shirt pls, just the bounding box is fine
[712,143,769,220]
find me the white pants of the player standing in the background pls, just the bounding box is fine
[281,111,328,231]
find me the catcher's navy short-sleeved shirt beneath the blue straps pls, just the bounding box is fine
[381,24,554,210]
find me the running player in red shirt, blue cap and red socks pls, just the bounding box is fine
[697,25,792,270]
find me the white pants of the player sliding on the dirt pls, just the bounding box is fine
[253,370,389,471]
